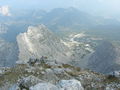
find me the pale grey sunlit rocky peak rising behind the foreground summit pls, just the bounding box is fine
[17,25,69,62]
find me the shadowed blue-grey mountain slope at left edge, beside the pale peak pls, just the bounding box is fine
[0,38,18,67]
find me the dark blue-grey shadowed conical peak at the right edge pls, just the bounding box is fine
[88,41,120,73]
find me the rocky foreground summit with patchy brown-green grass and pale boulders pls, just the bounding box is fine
[0,61,120,90]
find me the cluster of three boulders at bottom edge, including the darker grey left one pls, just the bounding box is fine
[10,76,84,90]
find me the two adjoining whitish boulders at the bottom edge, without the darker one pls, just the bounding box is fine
[30,80,84,90]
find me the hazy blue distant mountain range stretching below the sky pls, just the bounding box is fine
[0,8,120,41]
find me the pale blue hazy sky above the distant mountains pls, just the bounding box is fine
[0,0,120,17]
